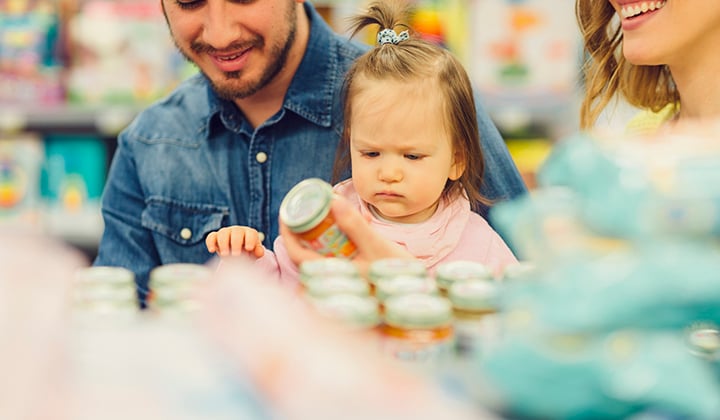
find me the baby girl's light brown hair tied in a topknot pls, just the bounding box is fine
[334,0,490,210]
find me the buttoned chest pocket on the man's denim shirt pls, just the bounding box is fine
[142,197,230,245]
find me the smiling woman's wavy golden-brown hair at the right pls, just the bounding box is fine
[575,0,680,128]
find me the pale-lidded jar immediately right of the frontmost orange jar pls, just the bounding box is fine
[448,280,500,358]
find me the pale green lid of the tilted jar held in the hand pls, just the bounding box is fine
[280,178,333,232]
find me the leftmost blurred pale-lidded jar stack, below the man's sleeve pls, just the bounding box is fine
[73,266,139,315]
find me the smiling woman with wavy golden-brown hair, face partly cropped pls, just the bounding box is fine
[575,0,720,132]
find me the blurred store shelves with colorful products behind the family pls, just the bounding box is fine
[0,0,581,256]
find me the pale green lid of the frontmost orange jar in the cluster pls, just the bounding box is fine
[385,293,452,328]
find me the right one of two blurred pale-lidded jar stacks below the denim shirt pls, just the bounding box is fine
[148,263,212,313]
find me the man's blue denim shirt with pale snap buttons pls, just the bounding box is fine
[94,2,525,302]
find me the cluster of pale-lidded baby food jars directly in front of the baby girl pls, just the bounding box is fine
[300,258,532,363]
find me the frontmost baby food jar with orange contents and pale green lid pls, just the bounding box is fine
[381,294,454,366]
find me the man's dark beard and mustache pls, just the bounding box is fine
[176,5,297,100]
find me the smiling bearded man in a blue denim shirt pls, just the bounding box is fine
[95,0,525,302]
